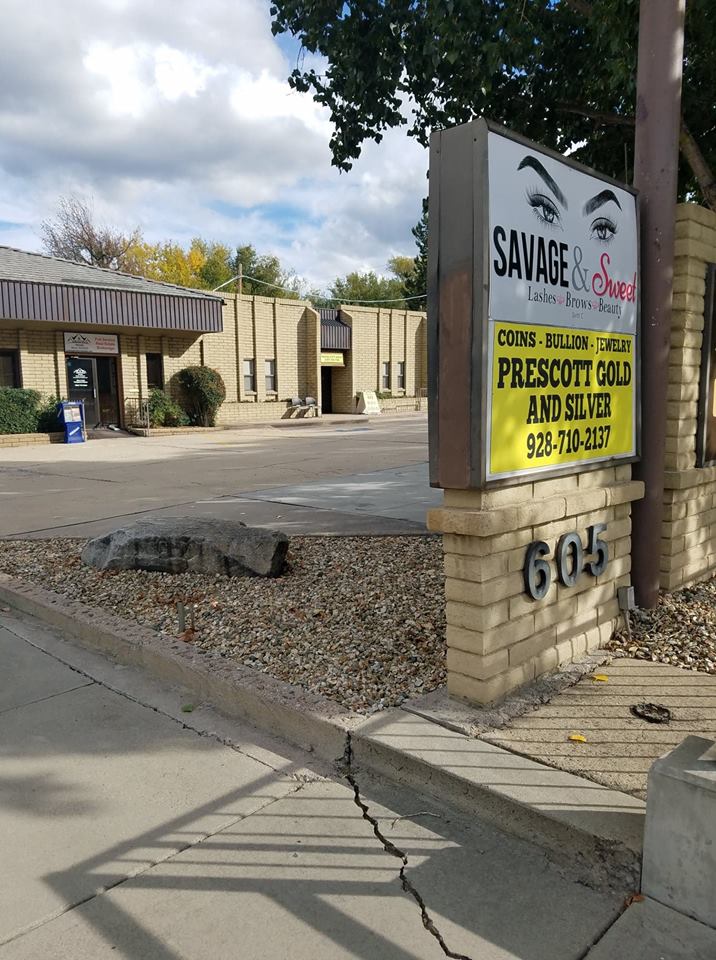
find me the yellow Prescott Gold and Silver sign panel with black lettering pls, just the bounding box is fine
[488,322,636,478]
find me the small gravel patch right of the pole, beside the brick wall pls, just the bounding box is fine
[607,577,716,674]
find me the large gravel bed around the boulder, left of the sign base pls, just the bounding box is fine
[0,537,445,713]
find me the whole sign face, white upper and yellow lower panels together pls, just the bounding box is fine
[484,130,639,480]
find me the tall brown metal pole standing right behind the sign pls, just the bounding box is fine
[632,0,686,608]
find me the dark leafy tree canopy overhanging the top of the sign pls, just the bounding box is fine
[271,0,716,209]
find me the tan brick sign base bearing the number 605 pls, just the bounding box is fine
[428,466,644,704]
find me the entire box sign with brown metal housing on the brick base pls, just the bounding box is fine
[428,120,639,488]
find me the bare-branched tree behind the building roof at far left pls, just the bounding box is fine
[40,195,142,272]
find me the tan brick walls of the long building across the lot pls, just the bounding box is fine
[0,294,427,425]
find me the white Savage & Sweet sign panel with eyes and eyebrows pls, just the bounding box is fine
[488,131,638,334]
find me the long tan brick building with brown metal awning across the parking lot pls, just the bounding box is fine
[0,247,427,426]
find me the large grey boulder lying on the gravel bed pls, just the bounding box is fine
[82,517,288,577]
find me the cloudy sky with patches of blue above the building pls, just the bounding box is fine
[0,0,427,289]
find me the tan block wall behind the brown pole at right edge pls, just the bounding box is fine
[661,203,716,590]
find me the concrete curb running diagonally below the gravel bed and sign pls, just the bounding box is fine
[0,574,645,892]
